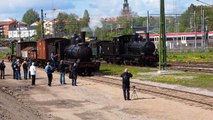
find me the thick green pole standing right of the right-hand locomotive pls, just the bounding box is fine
[159,0,167,71]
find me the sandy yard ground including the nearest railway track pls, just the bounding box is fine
[0,62,213,120]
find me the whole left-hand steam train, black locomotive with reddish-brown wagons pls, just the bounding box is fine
[12,32,100,75]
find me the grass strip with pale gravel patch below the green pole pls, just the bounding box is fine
[100,64,213,91]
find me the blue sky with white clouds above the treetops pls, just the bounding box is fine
[0,0,213,27]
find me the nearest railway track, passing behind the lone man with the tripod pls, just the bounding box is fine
[84,76,213,110]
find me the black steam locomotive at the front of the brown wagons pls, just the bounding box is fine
[64,32,100,75]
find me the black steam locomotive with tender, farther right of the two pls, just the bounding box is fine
[97,34,159,66]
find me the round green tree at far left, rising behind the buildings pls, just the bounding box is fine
[22,8,40,25]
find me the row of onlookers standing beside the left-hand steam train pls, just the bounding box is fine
[8,59,78,86]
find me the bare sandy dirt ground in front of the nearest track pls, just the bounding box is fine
[0,63,213,120]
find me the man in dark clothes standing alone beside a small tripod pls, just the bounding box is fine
[121,68,132,100]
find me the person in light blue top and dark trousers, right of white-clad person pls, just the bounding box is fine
[45,62,54,86]
